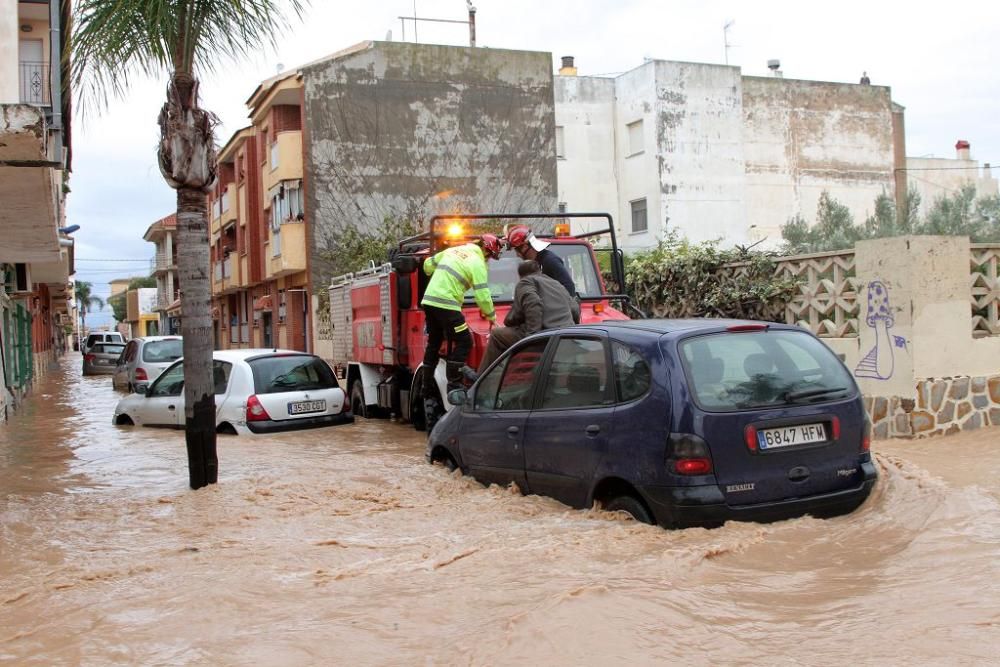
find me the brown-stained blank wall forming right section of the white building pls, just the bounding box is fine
[743,77,895,240]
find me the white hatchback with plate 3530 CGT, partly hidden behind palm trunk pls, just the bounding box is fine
[112,349,354,435]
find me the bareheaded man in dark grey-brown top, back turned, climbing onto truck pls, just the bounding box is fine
[479,259,574,373]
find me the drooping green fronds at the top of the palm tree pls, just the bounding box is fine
[70,0,309,111]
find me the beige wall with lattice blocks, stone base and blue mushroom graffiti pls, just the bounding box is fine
[778,236,1000,439]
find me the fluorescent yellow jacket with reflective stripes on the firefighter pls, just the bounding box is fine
[420,243,496,319]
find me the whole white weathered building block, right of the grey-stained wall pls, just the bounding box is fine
[554,60,905,250]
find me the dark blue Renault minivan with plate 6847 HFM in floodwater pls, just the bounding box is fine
[427,319,877,528]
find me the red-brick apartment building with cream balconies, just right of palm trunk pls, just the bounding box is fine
[209,73,310,350]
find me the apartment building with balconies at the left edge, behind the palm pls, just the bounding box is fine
[0,0,75,422]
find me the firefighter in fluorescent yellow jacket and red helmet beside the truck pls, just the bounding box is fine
[420,234,503,422]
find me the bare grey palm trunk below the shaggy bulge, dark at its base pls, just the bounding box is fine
[177,188,219,489]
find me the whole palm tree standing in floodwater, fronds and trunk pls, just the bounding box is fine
[71,0,308,489]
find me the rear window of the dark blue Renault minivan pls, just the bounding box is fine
[680,330,855,412]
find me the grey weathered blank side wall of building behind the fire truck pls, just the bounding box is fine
[302,42,557,285]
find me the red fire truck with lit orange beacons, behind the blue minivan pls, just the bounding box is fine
[329,213,641,431]
